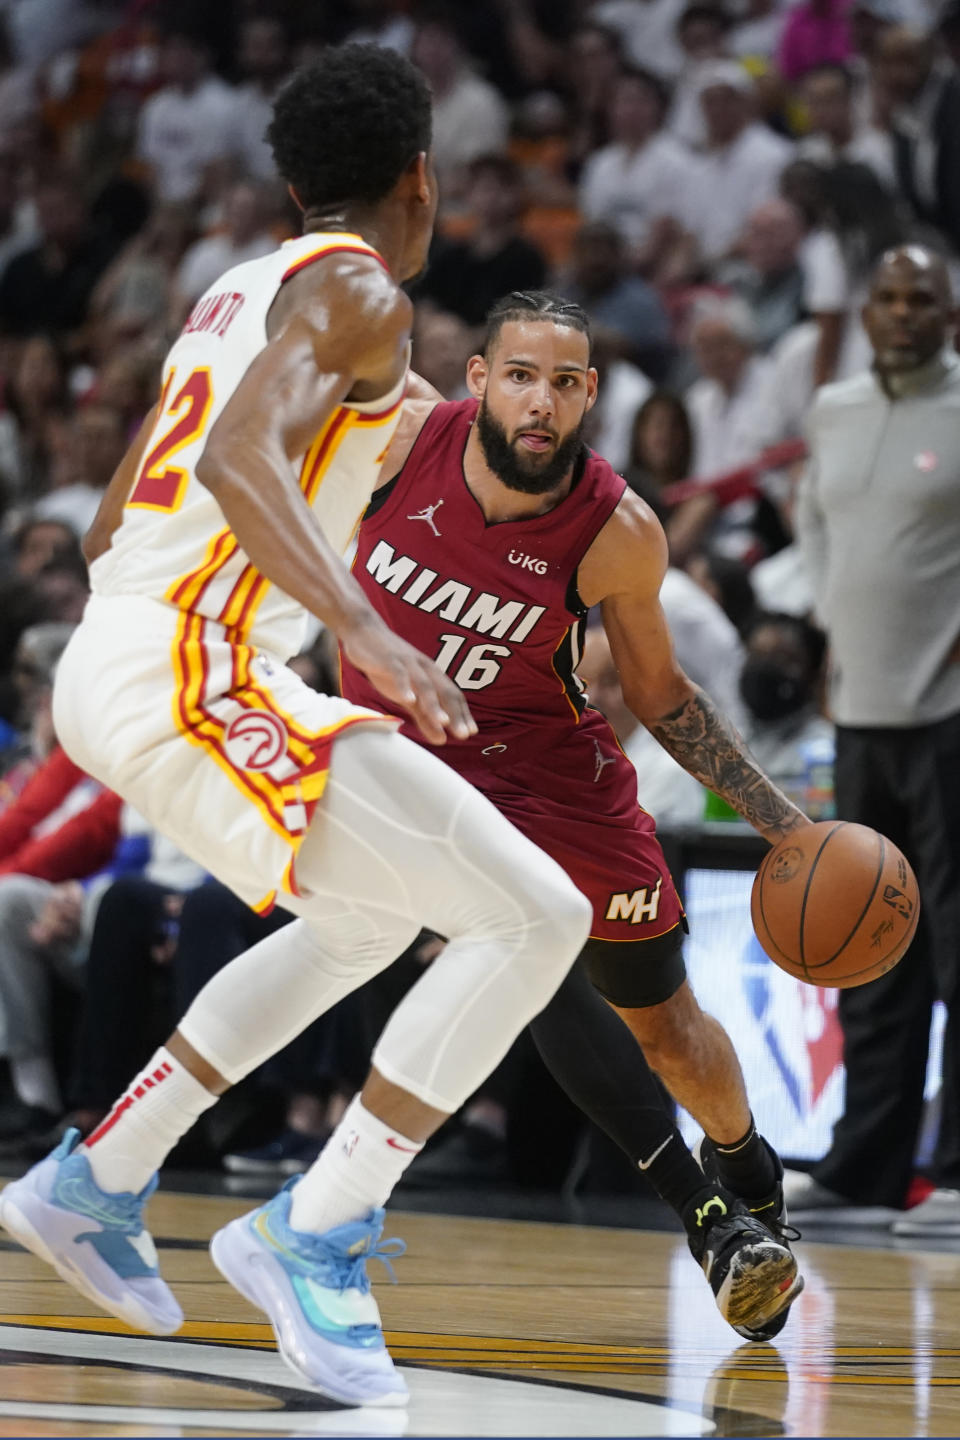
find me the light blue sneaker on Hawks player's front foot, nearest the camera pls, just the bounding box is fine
[210,1182,409,1405]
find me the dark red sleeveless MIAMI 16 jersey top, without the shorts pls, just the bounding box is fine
[343,400,626,753]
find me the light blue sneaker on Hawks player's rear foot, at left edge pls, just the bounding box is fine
[0,1130,183,1335]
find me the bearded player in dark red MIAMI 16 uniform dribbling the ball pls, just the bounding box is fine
[343,292,807,1339]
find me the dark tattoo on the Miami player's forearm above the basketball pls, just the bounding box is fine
[646,685,805,842]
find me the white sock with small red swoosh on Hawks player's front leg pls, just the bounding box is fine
[289,1094,423,1234]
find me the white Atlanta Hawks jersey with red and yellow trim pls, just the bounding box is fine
[91,233,406,660]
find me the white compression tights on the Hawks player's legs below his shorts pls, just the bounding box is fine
[180,727,590,1112]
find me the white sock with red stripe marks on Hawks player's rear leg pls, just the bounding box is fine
[83,1045,217,1195]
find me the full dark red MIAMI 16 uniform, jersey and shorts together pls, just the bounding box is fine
[341,400,682,940]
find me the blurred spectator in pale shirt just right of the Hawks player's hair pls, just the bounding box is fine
[410,6,510,207]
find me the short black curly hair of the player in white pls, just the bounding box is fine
[266,45,430,210]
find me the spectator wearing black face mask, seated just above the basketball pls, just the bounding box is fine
[740,613,833,818]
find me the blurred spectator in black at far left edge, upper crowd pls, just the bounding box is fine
[0,174,117,348]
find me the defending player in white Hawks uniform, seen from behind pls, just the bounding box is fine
[0,46,590,1404]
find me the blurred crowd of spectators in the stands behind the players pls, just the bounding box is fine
[0,0,960,1171]
